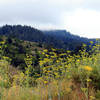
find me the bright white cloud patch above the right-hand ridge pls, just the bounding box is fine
[63,9,100,38]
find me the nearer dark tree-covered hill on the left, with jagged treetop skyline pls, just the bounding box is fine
[0,25,45,42]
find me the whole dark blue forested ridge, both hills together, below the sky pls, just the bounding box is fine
[0,25,95,50]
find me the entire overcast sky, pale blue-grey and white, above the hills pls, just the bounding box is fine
[0,0,100,38]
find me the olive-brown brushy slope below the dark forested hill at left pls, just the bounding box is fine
[0,36,45,70]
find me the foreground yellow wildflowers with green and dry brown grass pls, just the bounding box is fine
[0,41,100,100]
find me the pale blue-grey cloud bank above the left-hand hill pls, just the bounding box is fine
[0,0,59,24]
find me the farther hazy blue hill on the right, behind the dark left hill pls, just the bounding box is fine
[43,30,90,50]
